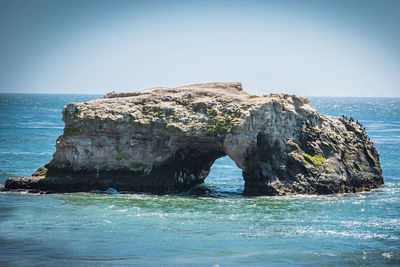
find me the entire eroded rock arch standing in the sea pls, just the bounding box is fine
[6,83,383,195]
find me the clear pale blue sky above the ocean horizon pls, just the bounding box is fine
[0,0,400,97]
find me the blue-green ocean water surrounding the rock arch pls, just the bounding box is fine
[0,94,400,266]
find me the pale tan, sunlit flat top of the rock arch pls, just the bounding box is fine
[63,82,316,132]
